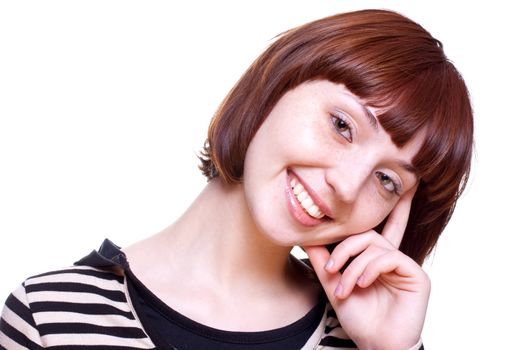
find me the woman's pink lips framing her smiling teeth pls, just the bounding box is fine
[285,170,329,227]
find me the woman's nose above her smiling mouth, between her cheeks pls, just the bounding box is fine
[325,157,373,204]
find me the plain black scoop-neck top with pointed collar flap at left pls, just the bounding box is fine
[75,239,327,350]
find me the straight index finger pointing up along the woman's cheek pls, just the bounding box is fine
[382,186,417,248]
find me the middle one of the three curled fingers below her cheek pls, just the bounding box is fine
[335,245,390,299]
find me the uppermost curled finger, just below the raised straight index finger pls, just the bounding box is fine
[325,230,393,273]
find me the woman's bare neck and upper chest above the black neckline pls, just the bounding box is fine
[125,180,318,330]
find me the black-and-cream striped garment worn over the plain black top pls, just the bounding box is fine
[0,241,362,350]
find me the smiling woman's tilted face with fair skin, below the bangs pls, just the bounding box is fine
[243,80,422,245]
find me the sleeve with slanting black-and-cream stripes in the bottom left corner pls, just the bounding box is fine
[0,284,44,350]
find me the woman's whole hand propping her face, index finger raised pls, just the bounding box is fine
[304,189,430,350]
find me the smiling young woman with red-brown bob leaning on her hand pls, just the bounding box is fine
[0,10,473,350]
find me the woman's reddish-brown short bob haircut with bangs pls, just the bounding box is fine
[200,10,473,264]
